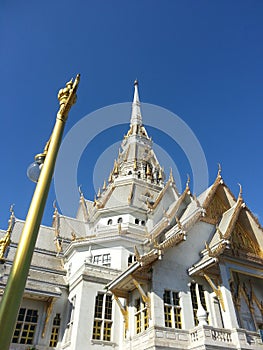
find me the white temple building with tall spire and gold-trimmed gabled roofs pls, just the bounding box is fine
[0,82,263,350]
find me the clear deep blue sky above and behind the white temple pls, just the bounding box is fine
[0,0,263,229]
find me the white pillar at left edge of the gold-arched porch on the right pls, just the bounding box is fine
[219,263,239,329]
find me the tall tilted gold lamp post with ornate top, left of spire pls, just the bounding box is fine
[0,74,80,350]
